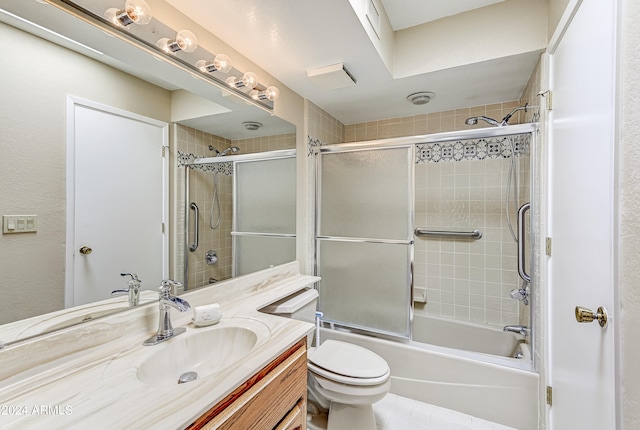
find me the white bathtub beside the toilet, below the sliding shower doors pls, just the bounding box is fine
[320,321,538,430]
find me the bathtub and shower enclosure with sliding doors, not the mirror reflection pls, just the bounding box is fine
[312,119,538,429]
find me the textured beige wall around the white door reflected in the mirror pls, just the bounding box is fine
[0,24,171,323]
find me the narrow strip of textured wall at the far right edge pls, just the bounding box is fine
[618,0,640,429]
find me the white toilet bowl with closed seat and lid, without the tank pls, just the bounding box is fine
[307,340,391,430]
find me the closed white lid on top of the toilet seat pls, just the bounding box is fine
[309,339,389,379]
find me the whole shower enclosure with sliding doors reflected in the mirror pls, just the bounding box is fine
[176,146,296,290]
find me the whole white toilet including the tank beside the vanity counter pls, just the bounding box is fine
[262,289,391,430]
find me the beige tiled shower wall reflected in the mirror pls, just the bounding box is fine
[174,124,295,288]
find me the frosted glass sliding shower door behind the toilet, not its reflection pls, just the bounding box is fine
[316,146,414,338]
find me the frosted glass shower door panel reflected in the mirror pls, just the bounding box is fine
[231,151,296,276]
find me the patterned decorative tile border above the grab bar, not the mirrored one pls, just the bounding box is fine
[416,134,530,164]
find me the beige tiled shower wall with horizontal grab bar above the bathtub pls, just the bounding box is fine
[414,138,529,326]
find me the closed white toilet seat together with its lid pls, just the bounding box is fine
[307,340,391,385]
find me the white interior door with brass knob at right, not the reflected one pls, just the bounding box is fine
[548,0,616,430]
